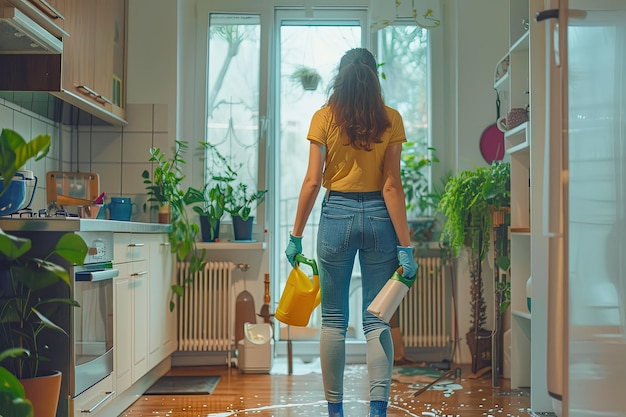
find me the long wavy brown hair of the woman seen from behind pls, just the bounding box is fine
[328,48,391,151]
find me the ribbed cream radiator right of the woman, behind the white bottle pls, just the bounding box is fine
[398,256,451,348]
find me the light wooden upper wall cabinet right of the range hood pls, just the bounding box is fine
[63,0,126,119]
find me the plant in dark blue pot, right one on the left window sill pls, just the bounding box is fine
[226,183,267,241]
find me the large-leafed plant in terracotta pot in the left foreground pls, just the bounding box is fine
[0,129,87,416]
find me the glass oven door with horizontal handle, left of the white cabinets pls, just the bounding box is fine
[71,262,119,397]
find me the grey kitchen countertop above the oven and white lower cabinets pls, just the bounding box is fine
[0,217,170,233]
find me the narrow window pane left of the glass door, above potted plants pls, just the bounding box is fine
[205,14,261,221]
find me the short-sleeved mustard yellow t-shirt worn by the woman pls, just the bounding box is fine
[307,106,406,192]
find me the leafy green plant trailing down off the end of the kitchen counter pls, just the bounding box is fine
[142,140,206,311]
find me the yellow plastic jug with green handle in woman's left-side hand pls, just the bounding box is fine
[274,255,322,326]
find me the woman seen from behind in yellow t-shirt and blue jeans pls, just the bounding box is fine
[285,48,417,417]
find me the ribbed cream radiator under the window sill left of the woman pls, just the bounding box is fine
[177,262,234,356]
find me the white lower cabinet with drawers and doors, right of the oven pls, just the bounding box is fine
[114,233,178,393]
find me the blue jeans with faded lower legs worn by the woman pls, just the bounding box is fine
[317,191,398,403]
